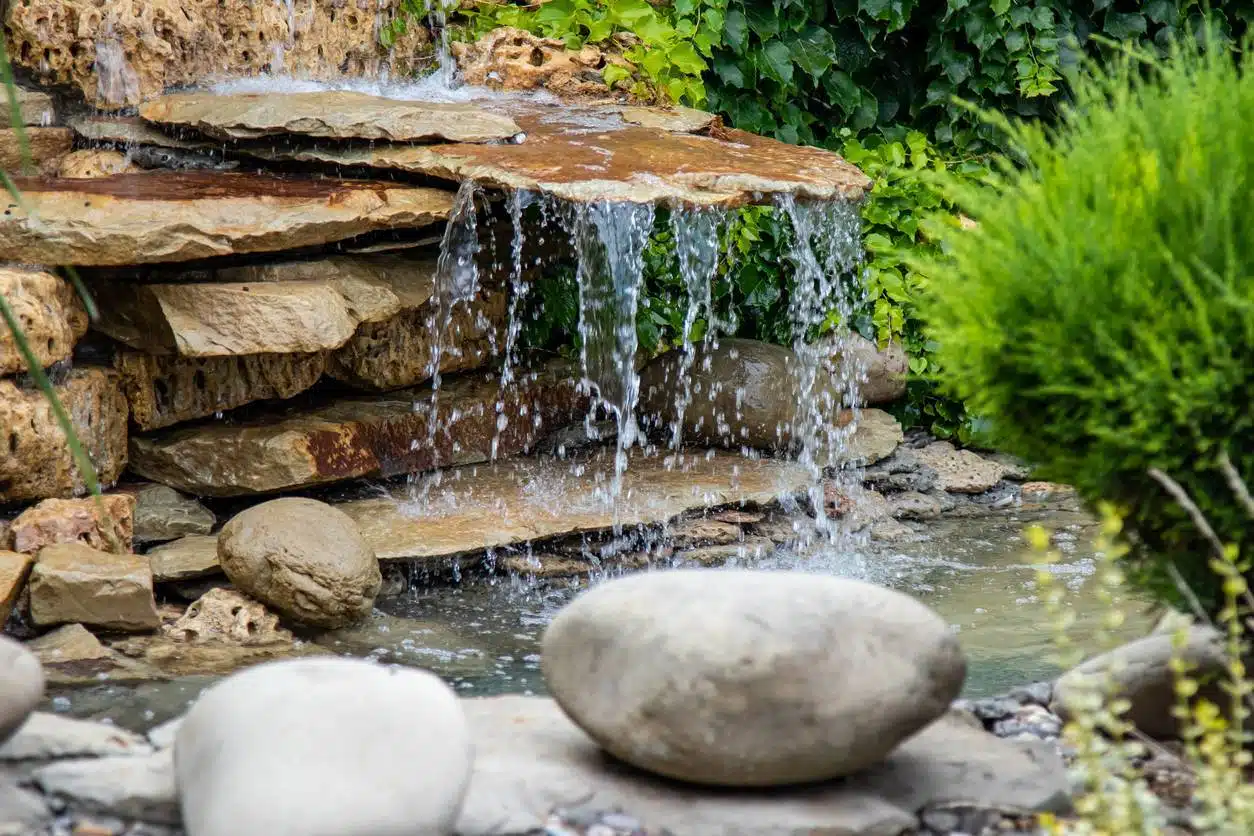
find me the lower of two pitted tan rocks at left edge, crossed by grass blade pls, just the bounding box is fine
[0,366,127,501]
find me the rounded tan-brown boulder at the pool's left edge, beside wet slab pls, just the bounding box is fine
[218,498,382,628]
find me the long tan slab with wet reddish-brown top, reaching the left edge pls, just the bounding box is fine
[0,170,453,266]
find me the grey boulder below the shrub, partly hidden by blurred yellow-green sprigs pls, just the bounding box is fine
[1050,627,1226,739]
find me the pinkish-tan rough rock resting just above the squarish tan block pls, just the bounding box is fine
[13,494,135,554]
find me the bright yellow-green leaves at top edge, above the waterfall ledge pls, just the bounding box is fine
[453,0,727,105]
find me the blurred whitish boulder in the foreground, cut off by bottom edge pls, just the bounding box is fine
[174,659,470,836]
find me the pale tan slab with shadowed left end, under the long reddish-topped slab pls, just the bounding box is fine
[95,282,357,357]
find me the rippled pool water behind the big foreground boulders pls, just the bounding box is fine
[50,501,1150,728]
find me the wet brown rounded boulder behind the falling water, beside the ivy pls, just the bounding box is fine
[638,338,902,464]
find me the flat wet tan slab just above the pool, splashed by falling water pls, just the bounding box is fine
[340,450,809,562]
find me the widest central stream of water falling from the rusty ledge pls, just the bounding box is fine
[569,202,653,498]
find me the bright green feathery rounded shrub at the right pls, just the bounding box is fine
[922,37,1254,613]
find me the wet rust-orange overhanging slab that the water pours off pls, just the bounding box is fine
[242,102,870,207]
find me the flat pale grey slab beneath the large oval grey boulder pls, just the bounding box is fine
[456,697,1068,836]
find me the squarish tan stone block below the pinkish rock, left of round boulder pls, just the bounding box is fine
[30,543,161,630]
